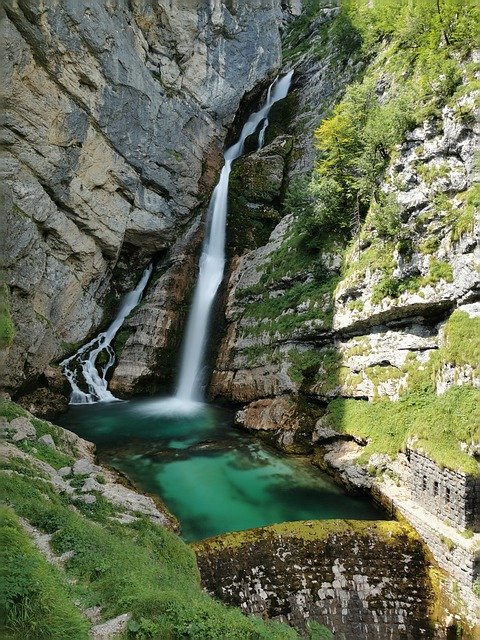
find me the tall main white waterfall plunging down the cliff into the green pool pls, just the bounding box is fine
[175,71,293,402]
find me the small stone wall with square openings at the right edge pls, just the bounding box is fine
[409,451,480,531]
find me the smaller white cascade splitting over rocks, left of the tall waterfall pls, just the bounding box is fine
[60,264,153,404]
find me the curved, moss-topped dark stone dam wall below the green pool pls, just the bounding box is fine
[194,520,433,640]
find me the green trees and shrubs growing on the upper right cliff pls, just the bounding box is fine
[287,0,478,247]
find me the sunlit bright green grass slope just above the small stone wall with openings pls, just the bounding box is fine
[288,310,480,474]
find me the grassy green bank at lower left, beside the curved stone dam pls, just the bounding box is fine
[0,403,298,640]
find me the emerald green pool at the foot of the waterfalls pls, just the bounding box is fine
[62,400,385,541]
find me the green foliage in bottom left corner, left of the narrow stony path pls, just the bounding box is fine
[0,507,89,640]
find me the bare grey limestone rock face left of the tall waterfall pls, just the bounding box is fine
[1,0,288,390]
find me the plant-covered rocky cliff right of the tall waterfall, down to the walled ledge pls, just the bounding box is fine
[211,3,480,637]
